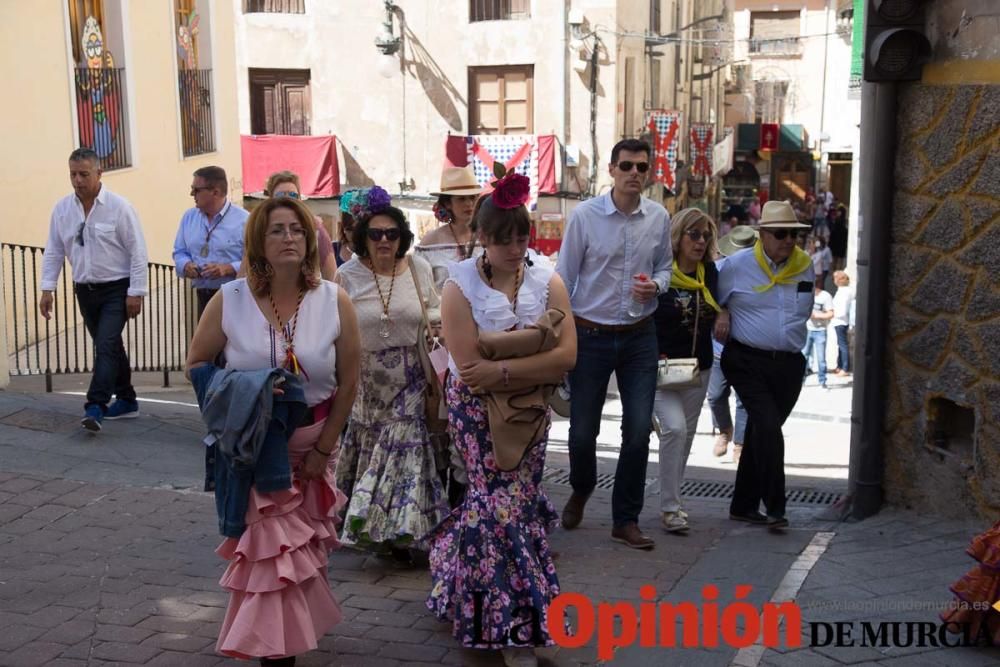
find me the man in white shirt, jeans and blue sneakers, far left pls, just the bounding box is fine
[38,148,148,432]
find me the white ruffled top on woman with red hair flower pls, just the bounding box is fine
[445,250,555,374]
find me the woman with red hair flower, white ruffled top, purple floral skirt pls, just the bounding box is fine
[427,175,576,666]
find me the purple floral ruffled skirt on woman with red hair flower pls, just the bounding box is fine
[427,378,559,649]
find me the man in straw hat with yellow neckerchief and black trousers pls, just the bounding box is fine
[715,201,815,529]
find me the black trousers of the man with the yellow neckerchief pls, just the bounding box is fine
[721,341,806,517]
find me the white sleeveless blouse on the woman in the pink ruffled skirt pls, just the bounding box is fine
[221,278,340,406]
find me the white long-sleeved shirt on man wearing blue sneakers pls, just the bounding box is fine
[41,185,149,296]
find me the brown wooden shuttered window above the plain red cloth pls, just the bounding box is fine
[249,69,312,135]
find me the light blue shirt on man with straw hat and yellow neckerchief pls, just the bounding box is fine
[719,248,815,352]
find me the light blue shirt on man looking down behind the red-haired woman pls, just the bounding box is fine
[174,202,250,289]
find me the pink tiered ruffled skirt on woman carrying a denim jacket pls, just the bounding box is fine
[216,421,347,659]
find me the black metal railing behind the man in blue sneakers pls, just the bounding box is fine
[0,243,197,391]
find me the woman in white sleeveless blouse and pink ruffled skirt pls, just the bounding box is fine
[187,198,360,665]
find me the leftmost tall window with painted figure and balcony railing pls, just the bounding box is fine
[66,0,132,171]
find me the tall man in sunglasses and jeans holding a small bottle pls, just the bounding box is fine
[556,139,673,549]
